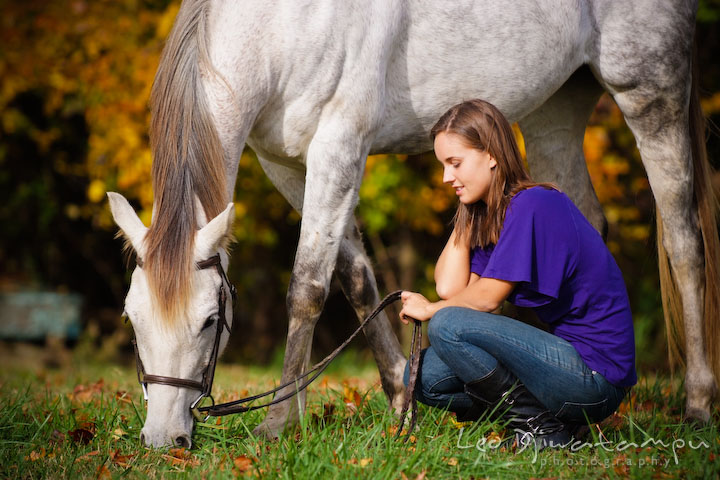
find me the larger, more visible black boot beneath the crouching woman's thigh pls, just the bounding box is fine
[465,363,571,450]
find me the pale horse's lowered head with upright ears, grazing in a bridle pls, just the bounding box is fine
[108,193,234,448]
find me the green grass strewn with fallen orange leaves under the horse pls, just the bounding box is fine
[0,344,720,479]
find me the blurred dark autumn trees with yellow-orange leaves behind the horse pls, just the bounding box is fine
[0,0,720,371]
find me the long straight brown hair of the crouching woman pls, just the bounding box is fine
[430,99,558,248]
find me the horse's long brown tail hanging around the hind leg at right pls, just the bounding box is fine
[657,38,720,383]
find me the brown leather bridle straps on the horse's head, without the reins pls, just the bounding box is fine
[132,254,237,421]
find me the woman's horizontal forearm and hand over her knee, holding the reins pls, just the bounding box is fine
[400,274,516,323]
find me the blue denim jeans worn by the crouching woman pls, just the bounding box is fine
[405,307,626,423]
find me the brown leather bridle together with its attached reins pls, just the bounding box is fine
[132,254,422,442]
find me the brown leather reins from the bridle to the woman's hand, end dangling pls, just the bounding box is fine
[197,290,422,442]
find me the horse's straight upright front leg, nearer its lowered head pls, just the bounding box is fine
[254,134,367,438]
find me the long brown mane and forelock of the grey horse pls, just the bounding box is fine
[143,0,227,326]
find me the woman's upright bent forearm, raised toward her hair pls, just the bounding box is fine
[435,230,470,300]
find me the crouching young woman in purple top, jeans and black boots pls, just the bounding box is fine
[400,100,637,448]
